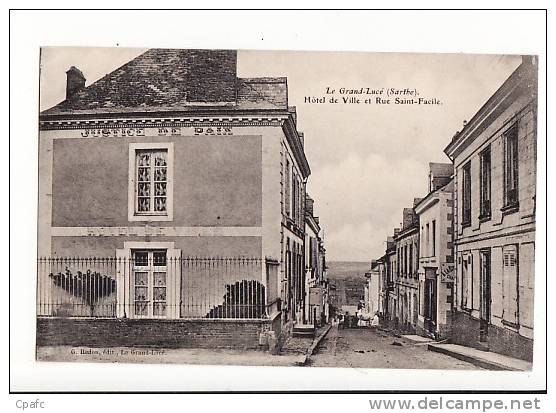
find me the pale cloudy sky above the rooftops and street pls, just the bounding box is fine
[40,48,521,261]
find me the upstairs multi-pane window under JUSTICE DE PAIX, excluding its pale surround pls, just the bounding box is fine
[135,150,168,214]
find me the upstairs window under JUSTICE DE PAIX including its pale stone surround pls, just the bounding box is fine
[128,142,173,221]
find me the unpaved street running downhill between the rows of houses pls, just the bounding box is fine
[308,326,479,370]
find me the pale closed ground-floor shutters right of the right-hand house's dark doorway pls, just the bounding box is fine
[502,245,519,326]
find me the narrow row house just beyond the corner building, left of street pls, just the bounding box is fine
[303,194,329,326]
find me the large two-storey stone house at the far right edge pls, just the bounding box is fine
[444,56,538,360]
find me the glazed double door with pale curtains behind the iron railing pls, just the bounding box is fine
[131,250,168,318]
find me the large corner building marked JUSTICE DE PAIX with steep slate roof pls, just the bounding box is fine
[37,49,310,347]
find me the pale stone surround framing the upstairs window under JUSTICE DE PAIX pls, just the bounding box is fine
[127,142,174,221]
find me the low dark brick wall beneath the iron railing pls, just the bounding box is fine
[37,317,271,350]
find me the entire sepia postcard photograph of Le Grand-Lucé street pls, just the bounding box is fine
[36,47,538,371]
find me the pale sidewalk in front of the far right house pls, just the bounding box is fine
[428,344,533,371]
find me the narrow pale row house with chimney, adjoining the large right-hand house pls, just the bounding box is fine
[415,163,455,340]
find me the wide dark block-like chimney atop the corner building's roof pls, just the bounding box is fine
[185,50,237,104]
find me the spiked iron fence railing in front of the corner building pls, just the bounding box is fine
[37,251,269,319]
